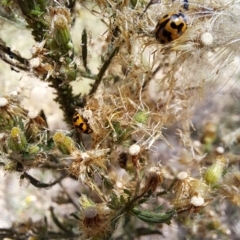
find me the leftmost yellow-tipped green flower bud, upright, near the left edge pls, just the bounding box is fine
[8,127,27,151]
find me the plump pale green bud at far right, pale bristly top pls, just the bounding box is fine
[204,156,226,185]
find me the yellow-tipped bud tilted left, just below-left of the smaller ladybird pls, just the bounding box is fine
[53,132,76,155]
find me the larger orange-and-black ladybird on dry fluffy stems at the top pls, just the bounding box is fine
[155,12,187,44]
